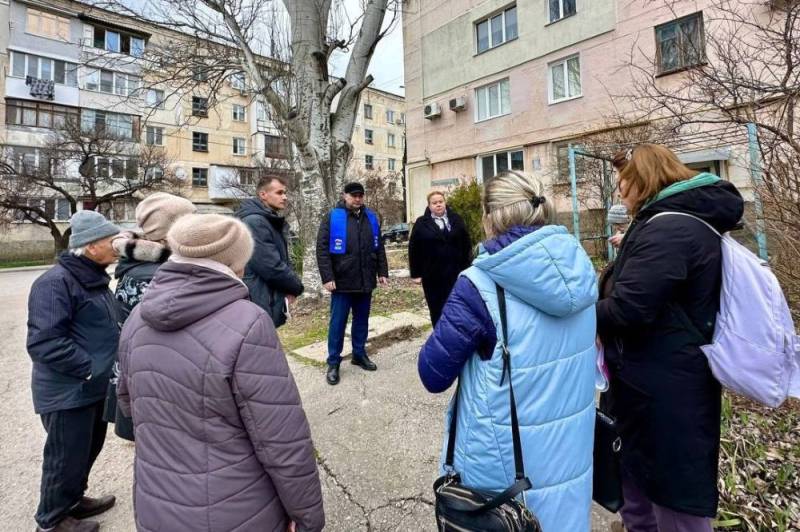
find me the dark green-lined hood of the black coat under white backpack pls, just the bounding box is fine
[637,173,744,233]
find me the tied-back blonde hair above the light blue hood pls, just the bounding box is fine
[483,170,555,238]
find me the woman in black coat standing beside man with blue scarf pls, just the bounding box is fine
[408,191,472,326]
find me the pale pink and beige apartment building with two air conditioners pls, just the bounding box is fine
[403,0,767,220]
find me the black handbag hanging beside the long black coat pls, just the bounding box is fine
[592,408,625,513]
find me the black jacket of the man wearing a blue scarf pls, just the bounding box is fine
[317,201,389,293]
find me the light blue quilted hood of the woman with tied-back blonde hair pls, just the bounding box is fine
[473,225,597,317]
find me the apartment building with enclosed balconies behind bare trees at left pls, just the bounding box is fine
[0,0,291,258]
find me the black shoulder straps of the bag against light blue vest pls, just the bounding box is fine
[444,283,531,484]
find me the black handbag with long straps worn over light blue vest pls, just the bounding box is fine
[433,285,542,532]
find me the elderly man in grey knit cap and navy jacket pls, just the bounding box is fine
[27,211,120,532]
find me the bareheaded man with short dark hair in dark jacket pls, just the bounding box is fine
[236,175,303,327]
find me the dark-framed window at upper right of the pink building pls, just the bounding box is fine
[653,11,707,76]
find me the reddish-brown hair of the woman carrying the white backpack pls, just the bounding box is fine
[612,144,699,215]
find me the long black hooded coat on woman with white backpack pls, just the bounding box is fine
[597,181,744,517]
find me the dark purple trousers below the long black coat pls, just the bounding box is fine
[619,469,713,532]
